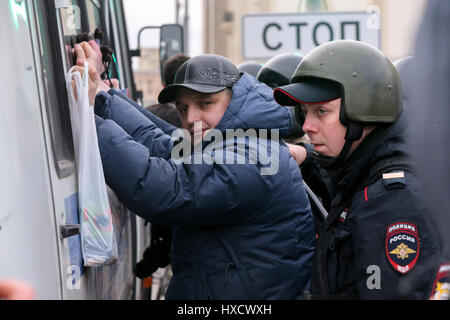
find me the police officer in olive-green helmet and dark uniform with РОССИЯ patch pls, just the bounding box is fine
[274,40,440,299]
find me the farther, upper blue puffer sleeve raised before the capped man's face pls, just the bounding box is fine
[95,92,173,159]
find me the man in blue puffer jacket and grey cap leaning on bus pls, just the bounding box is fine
[95,55,314,300]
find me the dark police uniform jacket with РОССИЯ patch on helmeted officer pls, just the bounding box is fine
[312,115,440,299]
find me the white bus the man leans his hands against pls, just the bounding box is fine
[0,0,150,299]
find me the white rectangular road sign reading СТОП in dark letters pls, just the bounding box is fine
[242,10,381,60]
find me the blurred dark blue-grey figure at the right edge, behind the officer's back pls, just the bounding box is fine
[409,0,450,300]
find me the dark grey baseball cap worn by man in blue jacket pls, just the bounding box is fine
[158,54,240,103]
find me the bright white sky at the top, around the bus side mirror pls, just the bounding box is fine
[123,0,203,55]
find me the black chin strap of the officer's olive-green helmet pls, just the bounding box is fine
[318,120,364,170]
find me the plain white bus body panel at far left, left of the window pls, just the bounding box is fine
[0,1,61,299]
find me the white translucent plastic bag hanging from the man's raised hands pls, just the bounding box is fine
[66,63,118,267]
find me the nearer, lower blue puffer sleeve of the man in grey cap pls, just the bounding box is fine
[96,117,269,227]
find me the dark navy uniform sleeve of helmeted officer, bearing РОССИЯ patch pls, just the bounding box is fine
[350,173,440,299]
